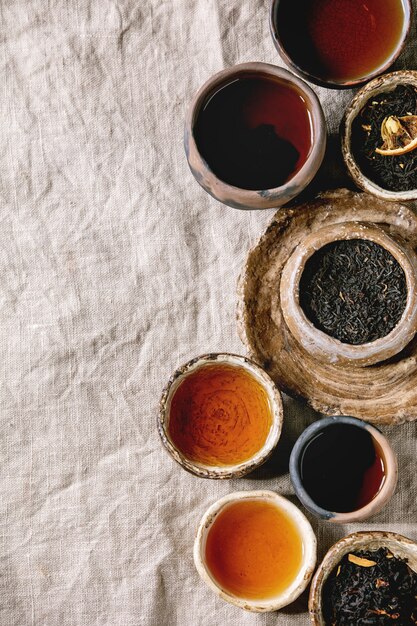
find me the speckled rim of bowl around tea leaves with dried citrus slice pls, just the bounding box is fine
[340,70,417,202]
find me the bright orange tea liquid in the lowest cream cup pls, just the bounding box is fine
[205,500,303,600]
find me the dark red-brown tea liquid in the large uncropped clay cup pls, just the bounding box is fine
[194,75,312,190]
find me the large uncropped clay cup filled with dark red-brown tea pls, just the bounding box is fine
[184,63,326,209]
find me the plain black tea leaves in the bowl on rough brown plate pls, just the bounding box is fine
[299,239,407,345]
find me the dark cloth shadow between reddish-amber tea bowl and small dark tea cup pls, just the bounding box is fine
[245,396,320,480]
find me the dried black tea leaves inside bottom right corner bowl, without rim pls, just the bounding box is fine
[323,548,417,626]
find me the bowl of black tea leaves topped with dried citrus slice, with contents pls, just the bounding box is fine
[340,70,417,202]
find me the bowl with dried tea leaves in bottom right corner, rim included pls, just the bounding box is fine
[309,531,417,626]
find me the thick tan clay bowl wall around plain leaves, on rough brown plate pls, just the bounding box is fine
[280,222,417,366]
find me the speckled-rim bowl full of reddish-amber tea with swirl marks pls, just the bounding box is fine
[158,353,283,479]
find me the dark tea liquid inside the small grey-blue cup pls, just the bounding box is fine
[300,424,385,513]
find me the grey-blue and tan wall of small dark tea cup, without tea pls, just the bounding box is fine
[290,416,398,524]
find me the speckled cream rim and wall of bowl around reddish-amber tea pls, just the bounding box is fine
[158,354,283,478]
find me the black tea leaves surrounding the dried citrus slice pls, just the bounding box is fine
[352,85,417,191]
